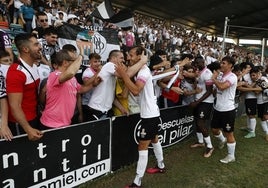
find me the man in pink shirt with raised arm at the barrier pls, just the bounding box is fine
[40,50,93,129]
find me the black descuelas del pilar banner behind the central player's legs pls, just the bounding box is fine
[112,106,194,170]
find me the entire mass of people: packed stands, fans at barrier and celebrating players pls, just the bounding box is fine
[0,0,268,187]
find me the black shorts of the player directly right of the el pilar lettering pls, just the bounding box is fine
[194,102,213,119]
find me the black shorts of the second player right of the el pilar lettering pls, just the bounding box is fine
[211,109,236,132]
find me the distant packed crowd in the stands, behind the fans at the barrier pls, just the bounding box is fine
[0,0,266,65]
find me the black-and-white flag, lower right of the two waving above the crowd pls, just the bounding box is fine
[110,9,134,28]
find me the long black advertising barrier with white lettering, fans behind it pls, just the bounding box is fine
[0,106,194,188]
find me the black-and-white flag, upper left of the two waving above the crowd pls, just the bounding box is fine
[91,0,115,21]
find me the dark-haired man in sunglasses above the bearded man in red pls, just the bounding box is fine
[32,12,49,38]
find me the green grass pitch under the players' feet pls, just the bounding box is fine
[80,116,268,188]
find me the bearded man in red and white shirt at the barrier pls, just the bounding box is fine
[6,33,43,140]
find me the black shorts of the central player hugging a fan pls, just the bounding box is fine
[139,117,161,140]
